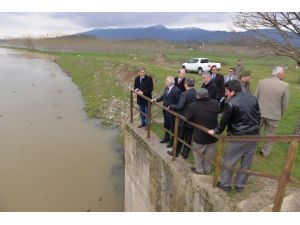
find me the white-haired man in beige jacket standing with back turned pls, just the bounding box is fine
[255,66,289,157]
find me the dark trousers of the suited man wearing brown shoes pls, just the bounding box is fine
[176,121,193,159]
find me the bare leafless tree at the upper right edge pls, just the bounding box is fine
[234,12,300,134]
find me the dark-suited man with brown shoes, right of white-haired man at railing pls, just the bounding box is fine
[167,78,196,159]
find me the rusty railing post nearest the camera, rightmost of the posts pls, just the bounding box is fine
[272,141,299,212]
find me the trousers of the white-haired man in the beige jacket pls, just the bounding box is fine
[260,117,279,157]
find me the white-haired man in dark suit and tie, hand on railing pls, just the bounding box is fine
[152,76,181,147]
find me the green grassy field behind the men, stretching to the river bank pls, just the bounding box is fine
[31,43,300,181]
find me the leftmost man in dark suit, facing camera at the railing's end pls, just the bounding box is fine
[134,67,153,128]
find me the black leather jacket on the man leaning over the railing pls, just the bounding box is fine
[215,92,260,135]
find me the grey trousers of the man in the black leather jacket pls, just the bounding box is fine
[220,141,257,187]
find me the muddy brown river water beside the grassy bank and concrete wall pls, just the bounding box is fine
[0,48,124,212]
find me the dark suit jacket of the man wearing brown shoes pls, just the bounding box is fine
[169,88,196,116]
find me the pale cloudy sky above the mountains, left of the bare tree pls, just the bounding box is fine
[0,12,234,38]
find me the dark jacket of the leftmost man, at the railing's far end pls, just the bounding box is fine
[134,75,153,105]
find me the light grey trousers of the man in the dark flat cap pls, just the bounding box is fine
[193,142,216,173]
